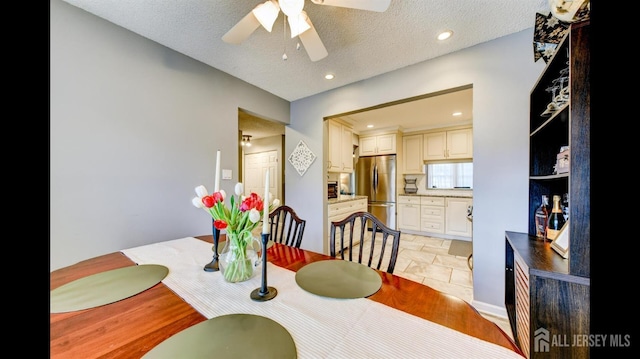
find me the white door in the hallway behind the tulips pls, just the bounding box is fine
[243,151,282,200]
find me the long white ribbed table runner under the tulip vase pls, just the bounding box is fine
[122,237,522,359]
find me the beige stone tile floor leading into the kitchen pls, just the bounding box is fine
[393,233,513,338]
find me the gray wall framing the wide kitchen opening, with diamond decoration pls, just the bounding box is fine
[285,31,544,315]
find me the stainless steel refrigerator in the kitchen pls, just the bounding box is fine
[355,155,396,229]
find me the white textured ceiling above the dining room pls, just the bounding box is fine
[64,0,549,101]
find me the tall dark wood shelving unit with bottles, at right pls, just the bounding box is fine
[505,20,591,358]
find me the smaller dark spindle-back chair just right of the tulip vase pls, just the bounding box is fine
[269,205,307,248]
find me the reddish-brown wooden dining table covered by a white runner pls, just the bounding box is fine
[49,234,524,359]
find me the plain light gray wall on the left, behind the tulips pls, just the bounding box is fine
[49,0,289,270]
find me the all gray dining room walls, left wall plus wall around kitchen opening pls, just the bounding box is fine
[50,0,544,315]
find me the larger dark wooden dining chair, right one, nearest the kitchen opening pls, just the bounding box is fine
[329,212,401,273]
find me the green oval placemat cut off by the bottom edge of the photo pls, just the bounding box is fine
[143,314,298,359]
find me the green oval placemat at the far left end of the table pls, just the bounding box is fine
[50,264,169,313]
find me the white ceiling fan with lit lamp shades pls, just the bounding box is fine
[222,0,391,61]
